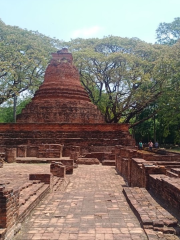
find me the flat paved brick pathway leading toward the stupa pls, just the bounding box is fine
[14,165,147,240]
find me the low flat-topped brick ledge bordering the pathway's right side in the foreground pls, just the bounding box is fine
[123,187,178,235]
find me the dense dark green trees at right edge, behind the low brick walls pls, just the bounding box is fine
[133,42,180,144]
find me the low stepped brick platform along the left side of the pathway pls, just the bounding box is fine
[0,163,69,239]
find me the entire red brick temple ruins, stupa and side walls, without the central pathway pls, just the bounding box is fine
[0,48,180,240]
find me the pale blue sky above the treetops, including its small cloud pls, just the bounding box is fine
[0,0,180,43]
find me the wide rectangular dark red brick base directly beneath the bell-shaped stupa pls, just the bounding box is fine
[0,123,134,149]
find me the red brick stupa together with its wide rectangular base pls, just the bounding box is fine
[0,49,135,157]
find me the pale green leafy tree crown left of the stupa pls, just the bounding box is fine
[0,20,61,104]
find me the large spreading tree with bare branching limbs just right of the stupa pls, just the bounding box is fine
[67,36,169,125]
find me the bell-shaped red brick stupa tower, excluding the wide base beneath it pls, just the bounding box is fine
[17,48,104,123]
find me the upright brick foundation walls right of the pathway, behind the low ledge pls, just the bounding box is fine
[115,146,180,234]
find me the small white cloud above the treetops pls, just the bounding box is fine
[71,26,101,38]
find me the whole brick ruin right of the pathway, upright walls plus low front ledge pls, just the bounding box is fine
[115,146,180,239]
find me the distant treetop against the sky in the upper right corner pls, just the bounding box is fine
[156,17,180,45]
